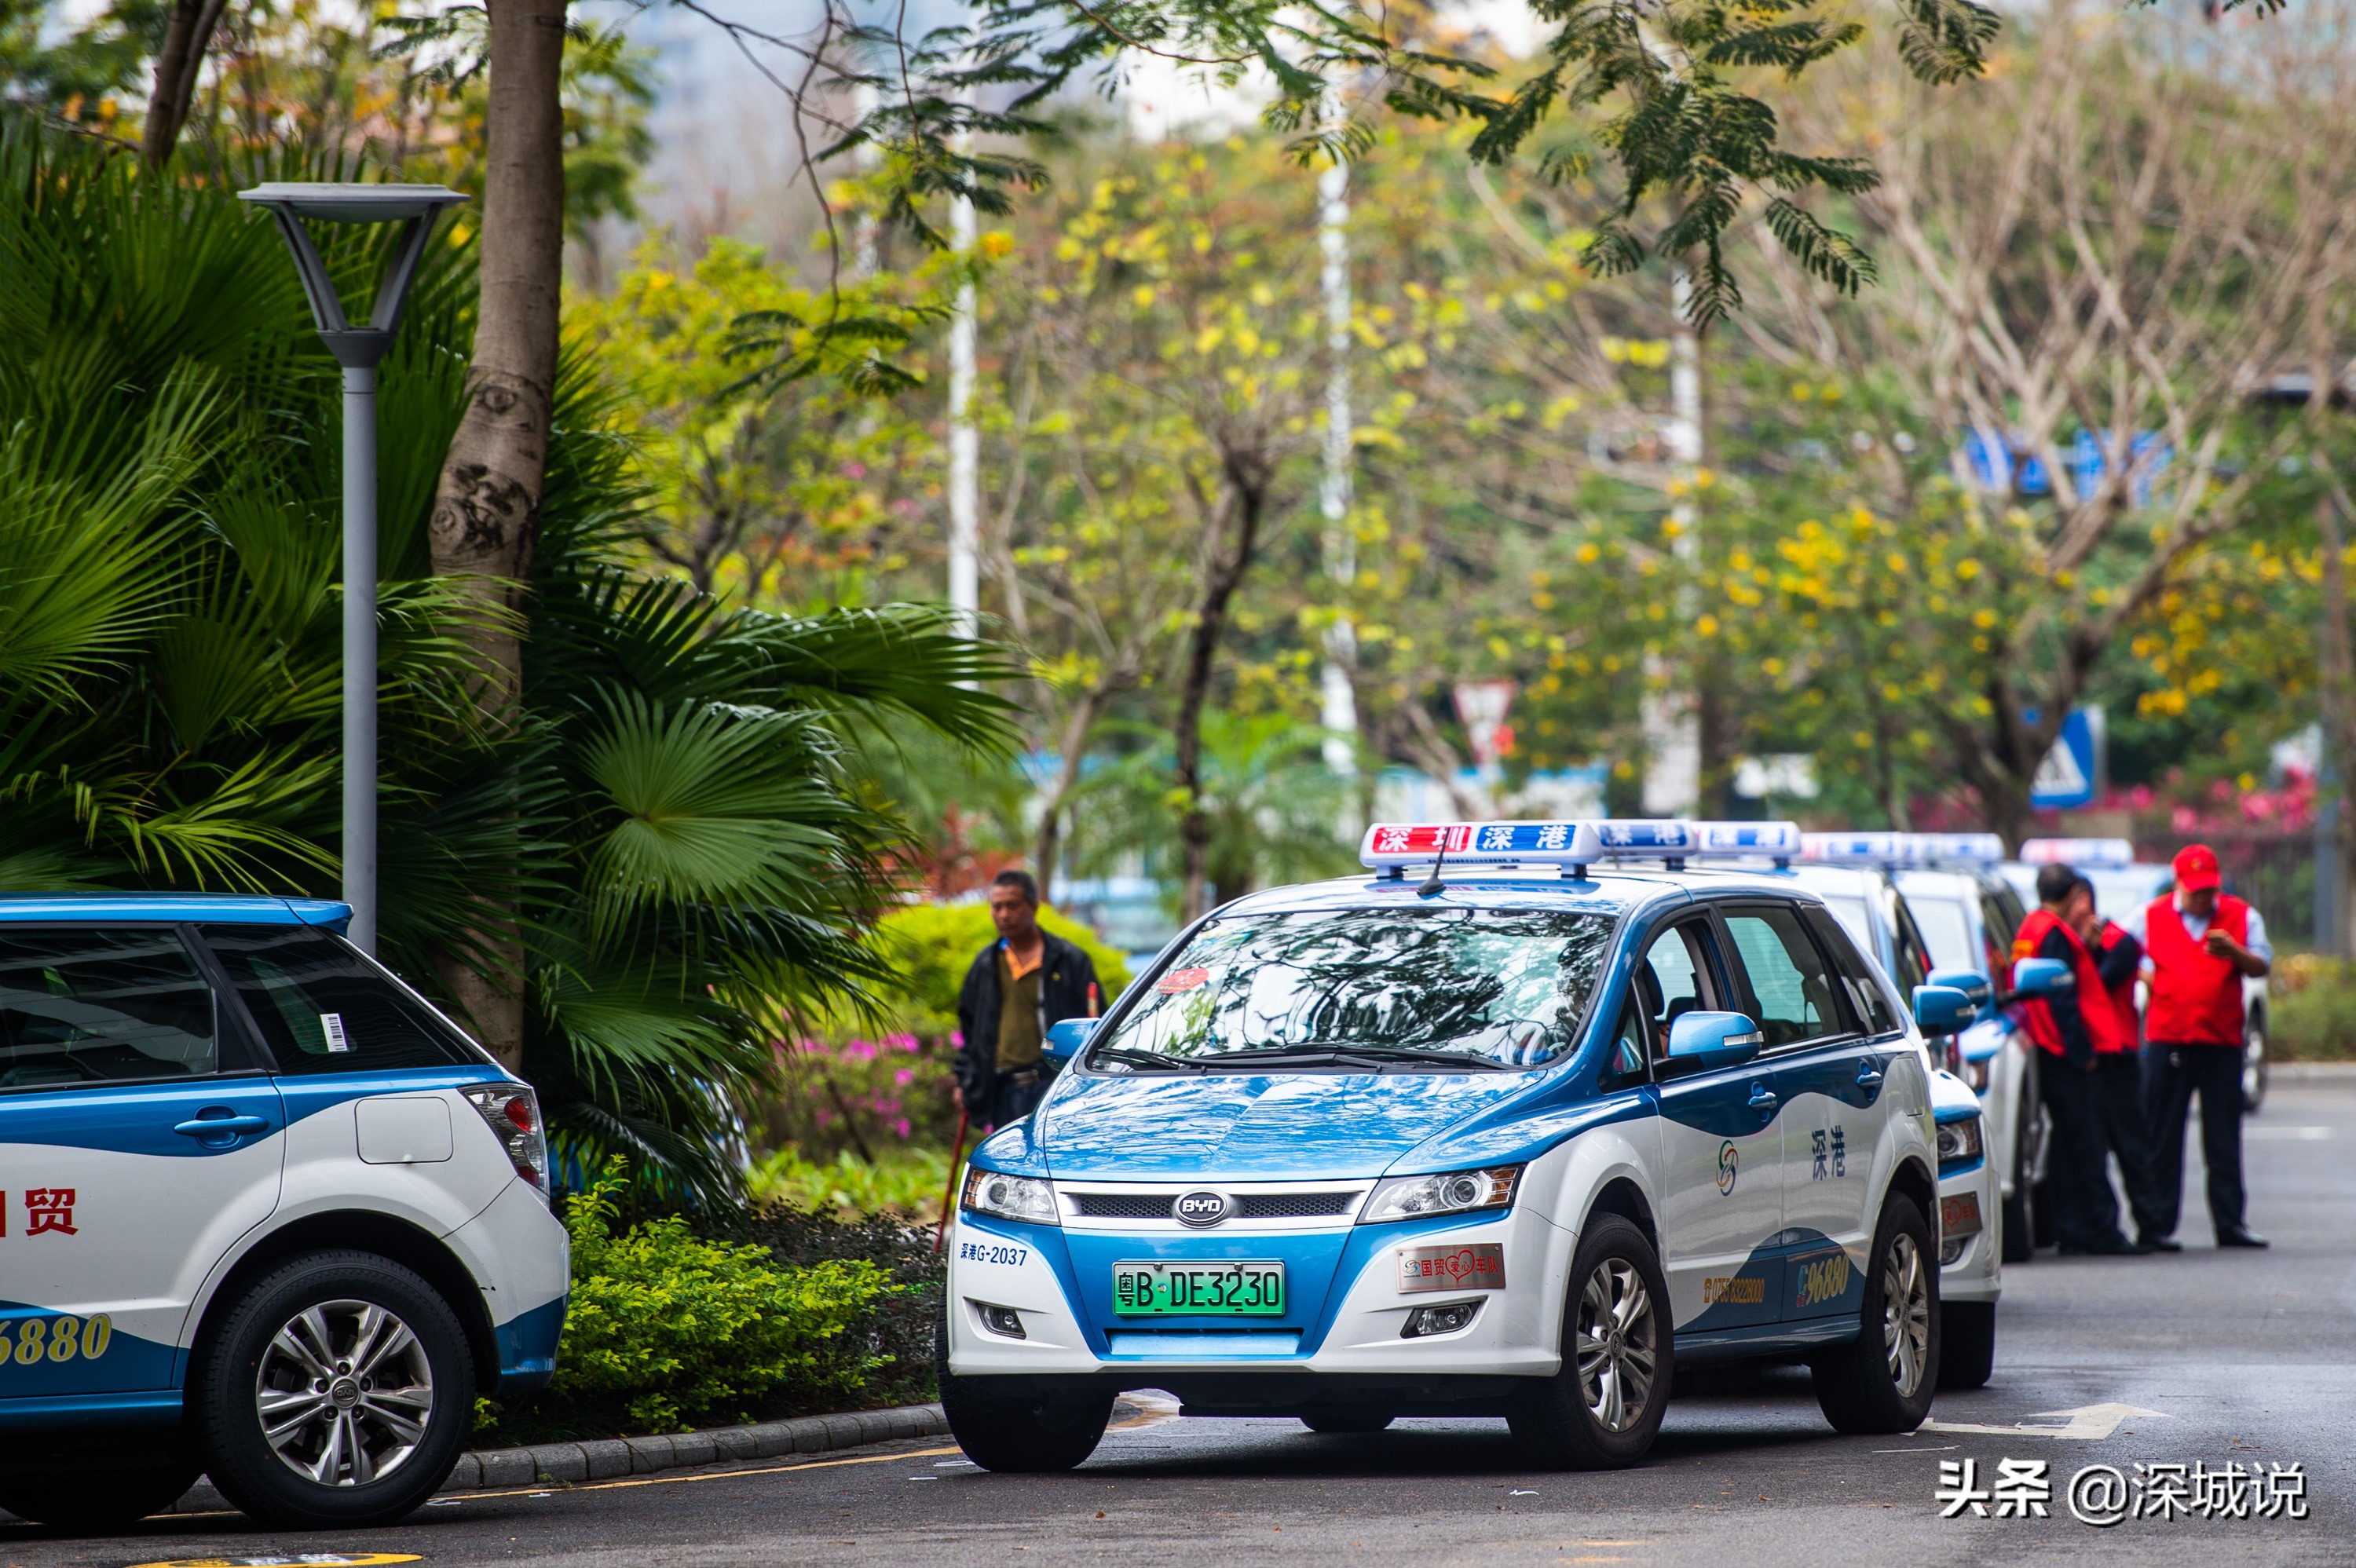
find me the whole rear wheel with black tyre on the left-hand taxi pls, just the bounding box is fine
[188,1252,476,1530]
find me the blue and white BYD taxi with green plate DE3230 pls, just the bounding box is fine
[940,821,1970,1469]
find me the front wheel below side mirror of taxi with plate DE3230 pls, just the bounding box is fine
[1505,1215,1677,1469]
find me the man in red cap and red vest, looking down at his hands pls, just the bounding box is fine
[2144,842,2274,1248]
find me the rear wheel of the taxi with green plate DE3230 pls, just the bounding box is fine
[1809,1191,1939,1434]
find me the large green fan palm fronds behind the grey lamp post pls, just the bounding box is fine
[0,122,1008,1193]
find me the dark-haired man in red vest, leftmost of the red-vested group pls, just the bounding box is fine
[2012,866,2151,1255]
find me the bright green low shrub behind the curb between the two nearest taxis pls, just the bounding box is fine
[544,1165,895,1431]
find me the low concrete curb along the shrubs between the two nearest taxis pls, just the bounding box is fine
[172,1405,949,1514]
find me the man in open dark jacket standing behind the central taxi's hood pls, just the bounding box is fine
[957,871,1103,1130]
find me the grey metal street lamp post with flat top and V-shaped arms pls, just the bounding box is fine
[238,184,466,953]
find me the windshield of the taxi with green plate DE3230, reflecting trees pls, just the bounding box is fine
[1088,908,1614,1073]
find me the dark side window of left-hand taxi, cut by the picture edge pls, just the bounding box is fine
[0,927,221,1087]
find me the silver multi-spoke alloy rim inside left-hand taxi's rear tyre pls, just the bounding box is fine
[254,1302,434,1486]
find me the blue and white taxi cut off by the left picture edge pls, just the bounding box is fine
[0,894,568,1528]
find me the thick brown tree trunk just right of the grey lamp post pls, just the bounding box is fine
[429,0,565,1069]
